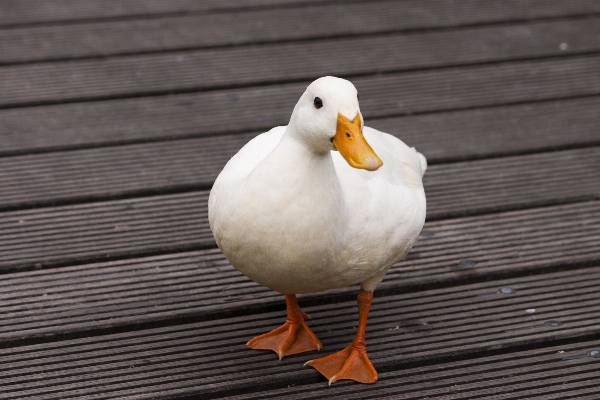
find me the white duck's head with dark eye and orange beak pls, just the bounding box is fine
[288,76,383,171]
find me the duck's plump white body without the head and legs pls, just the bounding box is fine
[209,98,426,294]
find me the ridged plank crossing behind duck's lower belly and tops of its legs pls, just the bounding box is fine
[0,202,600,345]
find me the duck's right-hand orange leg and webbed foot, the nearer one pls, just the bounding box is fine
[304,289,377,385]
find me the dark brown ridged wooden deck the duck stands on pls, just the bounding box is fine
[0,0,600,400]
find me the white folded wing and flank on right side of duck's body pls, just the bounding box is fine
[333,127,427,288]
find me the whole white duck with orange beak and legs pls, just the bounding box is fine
[208,77,427,384]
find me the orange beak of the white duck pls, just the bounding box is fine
[333,112,383,171]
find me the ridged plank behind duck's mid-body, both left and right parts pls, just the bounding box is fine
[0,148,600,271]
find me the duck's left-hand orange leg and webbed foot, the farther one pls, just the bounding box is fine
[246,294,323,360]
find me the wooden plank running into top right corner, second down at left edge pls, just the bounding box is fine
[0,0,600,63]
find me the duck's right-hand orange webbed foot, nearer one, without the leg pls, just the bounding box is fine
[304,344,377,385]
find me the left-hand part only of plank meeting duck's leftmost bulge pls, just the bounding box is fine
[0,192,214,268]
